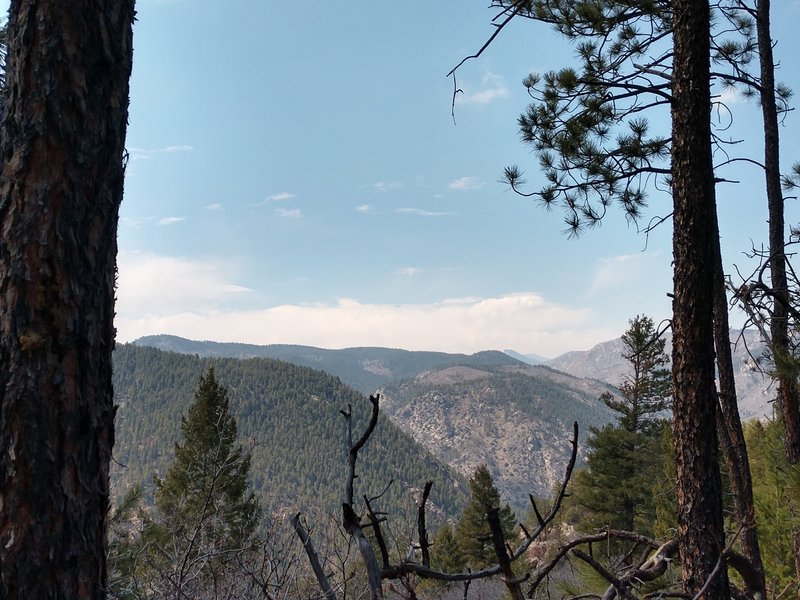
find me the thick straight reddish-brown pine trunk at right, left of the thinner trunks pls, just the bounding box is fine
[672,0,730,600]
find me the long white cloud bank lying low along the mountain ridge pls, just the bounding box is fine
[115,288,620,356]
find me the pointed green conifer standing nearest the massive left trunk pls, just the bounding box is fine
[150,368,260,595]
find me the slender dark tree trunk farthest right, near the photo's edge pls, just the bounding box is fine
[756,0,800,593]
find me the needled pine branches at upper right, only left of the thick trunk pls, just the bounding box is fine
[494,0,670,234]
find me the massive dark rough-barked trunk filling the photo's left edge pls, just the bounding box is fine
[0,0,134,600]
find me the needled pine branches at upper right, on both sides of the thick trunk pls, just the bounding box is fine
[492,0,791,235]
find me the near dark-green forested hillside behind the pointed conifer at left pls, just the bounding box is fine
[112,344,466,515]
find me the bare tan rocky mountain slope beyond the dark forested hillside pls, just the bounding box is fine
[381,365,611,509]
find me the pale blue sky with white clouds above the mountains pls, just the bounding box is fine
[18,0,800,357]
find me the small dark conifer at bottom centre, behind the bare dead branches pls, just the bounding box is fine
[455,465,516,569]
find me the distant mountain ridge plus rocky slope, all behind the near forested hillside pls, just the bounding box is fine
[130,336,612,508]
